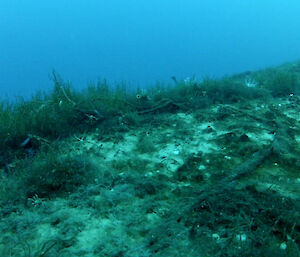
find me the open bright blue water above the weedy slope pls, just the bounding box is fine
[0,0,300,98]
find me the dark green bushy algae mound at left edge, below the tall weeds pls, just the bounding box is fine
[0,145,96,204]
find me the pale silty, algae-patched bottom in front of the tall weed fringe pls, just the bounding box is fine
[0,62,300,257]
